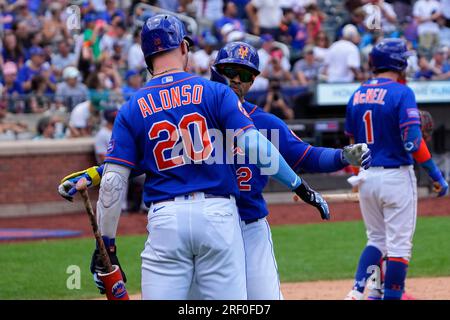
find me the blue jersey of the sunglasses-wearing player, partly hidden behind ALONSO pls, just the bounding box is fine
[236,102,311,220]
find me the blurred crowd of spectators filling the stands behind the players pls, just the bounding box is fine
[0,0,450,140]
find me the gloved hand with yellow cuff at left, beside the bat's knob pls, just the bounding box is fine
[58,166,103,201]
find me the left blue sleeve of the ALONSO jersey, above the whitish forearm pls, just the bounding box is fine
[105,104,138,168]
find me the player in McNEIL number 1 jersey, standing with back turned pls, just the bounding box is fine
[345,39,448,300]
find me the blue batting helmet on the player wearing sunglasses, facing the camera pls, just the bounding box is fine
[211,41,260,84]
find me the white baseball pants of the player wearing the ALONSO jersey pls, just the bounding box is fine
[141,192,247,300]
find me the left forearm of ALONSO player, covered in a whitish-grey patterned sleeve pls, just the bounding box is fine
[97,163,131,239]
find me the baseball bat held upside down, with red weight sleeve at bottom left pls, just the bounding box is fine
[75,178,130,300]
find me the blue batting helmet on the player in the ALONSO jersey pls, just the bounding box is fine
[141,14,194,58]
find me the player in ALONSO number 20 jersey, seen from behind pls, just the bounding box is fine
[60,14,329,299]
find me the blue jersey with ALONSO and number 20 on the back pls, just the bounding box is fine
[105,72,254,206]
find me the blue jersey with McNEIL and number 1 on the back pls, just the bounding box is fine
[345,78,420,167]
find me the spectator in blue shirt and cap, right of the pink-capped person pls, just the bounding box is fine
[18,47,56,94]
